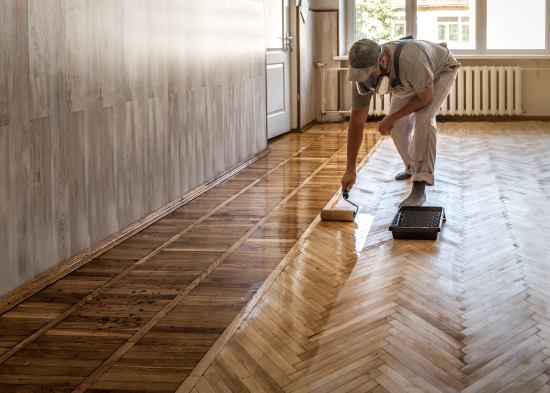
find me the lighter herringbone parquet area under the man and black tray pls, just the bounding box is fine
[182,122,550,393]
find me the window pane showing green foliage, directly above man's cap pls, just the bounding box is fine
[355,0,406,43]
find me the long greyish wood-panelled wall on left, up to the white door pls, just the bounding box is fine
[0,0,267,296]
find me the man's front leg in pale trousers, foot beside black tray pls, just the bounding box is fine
[400,69,458,206]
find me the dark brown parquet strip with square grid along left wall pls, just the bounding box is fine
[0,124,378,393]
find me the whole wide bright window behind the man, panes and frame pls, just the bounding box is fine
[352,0,550,55]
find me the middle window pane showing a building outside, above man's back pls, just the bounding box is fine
[415,0,474,49]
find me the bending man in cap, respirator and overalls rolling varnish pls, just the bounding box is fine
[342,39,460,206]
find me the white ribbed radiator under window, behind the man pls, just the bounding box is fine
[369,66,523,116]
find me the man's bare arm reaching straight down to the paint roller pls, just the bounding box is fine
[342,105,369,191]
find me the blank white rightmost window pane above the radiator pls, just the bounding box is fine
[487,0,546,49]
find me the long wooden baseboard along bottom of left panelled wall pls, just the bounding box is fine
[0,147,273,314]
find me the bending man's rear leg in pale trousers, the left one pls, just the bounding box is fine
[390,97,415,180]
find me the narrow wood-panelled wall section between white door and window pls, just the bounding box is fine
[299,10,340,128]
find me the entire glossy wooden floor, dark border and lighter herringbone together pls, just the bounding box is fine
[0,122,550,393]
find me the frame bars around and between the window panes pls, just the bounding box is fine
[345,0,550,56]
